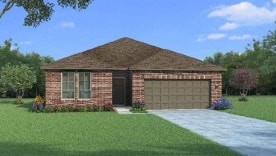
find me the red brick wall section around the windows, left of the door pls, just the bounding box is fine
[46,71,112,105]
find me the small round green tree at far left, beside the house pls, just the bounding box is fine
[0,64,36,101]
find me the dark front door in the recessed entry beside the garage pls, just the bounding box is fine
[112,77,126,105]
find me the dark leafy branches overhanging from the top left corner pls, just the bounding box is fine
[0,0,93,27]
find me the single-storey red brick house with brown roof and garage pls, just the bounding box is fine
[43,37,224,109]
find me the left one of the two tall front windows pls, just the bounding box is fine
[62,72,75,99]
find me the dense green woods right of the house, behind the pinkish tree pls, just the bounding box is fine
[205,26,276,94]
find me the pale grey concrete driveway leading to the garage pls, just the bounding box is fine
[149,109,276,156]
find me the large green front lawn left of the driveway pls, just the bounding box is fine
[0,99,239,156]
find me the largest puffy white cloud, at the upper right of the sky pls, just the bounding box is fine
[208,0,276,30]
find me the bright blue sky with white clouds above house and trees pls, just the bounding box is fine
[0,0,276,59]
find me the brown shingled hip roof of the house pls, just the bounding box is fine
[43,37,224,71]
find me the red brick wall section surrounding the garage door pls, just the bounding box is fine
[132,72,222,107]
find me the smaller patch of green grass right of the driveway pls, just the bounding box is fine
[224,96,276,122]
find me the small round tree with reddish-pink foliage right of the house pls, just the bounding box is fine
[230,68,258,99]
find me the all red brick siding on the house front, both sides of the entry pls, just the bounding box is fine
[46,71,222,105]
